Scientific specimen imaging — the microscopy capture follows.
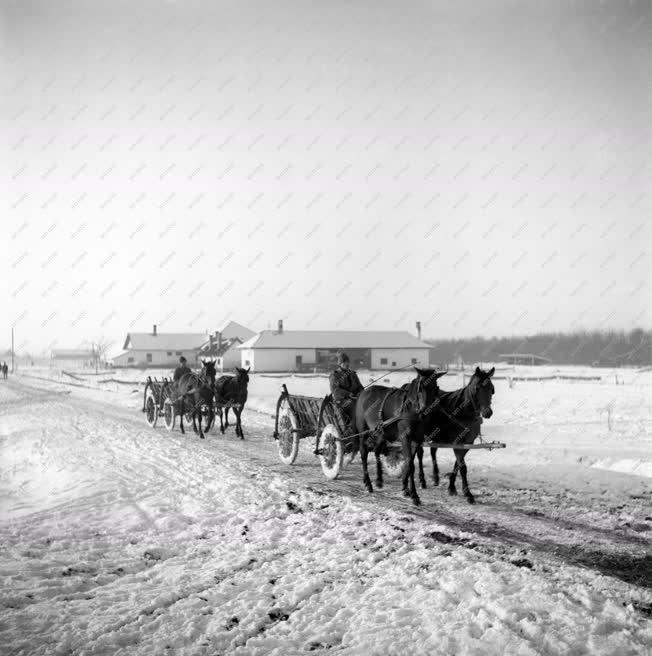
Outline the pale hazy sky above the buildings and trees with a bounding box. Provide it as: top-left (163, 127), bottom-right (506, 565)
top-left (0, 0), bottom-right (652, 352)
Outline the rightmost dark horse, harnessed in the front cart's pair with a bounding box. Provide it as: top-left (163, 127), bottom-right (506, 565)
top-left (417, 367), bottom-right (496, 503)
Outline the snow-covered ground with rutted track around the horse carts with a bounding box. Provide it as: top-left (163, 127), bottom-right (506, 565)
top-left (0, 367), bottom-right (652, 656)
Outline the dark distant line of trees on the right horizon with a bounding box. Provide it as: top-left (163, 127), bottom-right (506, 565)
top-left (425, 328), bottom-right (652, 367)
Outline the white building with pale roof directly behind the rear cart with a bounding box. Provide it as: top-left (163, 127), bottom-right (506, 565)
top-left (113, 326), bottom-right (208, 367)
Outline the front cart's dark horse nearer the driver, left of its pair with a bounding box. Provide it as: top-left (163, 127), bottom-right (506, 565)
top-left (355, 367), bottom-right (446, 506)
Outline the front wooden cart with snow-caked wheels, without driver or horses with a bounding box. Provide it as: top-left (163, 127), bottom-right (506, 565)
top-left (274, 384), bottom-right (506, 479)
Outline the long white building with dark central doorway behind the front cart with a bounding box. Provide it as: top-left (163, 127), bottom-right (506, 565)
top-left (238, 324), bottom-right (430, 372)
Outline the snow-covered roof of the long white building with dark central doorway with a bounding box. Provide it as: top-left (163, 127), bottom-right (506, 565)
top-left (238, 330), bottom-right (430, 349)
